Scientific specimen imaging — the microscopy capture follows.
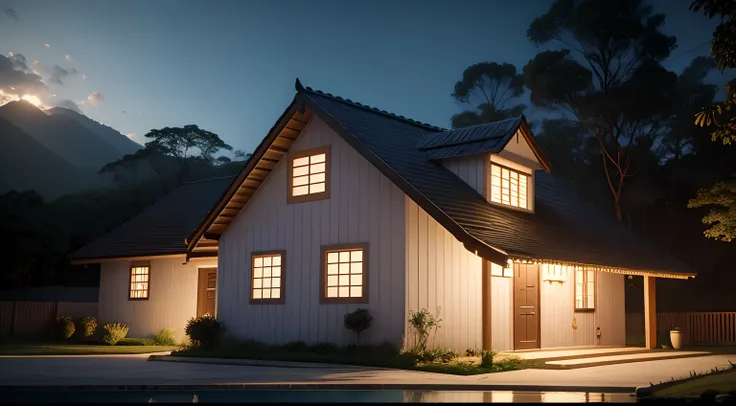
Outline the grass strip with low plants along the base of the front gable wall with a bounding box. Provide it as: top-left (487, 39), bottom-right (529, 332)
top-left (171, 341), bottom-right (526, 375)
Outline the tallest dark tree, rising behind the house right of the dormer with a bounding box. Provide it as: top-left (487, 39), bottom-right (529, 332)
top-left (523, 0), bottom-right (677, 221)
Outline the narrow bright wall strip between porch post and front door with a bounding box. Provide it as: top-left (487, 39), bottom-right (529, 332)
top-left (491, 276), bottom-right (514, 351)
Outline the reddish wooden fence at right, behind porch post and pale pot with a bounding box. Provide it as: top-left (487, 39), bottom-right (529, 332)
top-left (626, 312), bottom-right (736, 344)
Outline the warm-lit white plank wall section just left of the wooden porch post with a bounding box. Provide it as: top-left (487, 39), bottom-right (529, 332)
top-left (406, 197), bottom-right (482, 352)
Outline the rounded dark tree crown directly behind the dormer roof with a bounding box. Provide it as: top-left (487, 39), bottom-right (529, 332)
top-left (452, 62), bottom-right (526, 128)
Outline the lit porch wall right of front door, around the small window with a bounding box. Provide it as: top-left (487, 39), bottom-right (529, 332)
top-left (539, 272), bottom-right (626, 348)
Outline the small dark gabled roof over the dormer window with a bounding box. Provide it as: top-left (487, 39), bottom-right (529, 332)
top-left (417, 115), bottom-right (551, 172)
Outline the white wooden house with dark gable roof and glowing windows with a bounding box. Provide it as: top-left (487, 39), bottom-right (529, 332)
top-left (70, 80), bottom-right (695, 351)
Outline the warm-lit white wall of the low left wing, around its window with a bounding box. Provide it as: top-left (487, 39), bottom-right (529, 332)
top-left (98, 256), bottom-right (217, 341)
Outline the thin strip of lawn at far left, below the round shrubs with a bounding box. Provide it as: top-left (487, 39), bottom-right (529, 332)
top-left (0, 338), bottom-right (176, 355)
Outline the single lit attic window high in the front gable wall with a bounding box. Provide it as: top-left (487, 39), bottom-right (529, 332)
top-left (287, 146), bottom-right (330, 204)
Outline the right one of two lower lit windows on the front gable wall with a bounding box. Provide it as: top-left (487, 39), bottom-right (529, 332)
top-left (323, 246), bottom-right (367, 302)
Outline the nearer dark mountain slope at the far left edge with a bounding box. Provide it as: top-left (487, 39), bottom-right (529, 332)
top-left (0, 118), bottom-right (91, 199)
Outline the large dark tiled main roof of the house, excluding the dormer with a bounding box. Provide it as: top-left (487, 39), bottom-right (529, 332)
top-left (189, 80), bottom-right (695, 278)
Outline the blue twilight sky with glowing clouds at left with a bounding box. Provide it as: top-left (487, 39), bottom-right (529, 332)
top-left (0, 0), bottom-right (722, 152)
